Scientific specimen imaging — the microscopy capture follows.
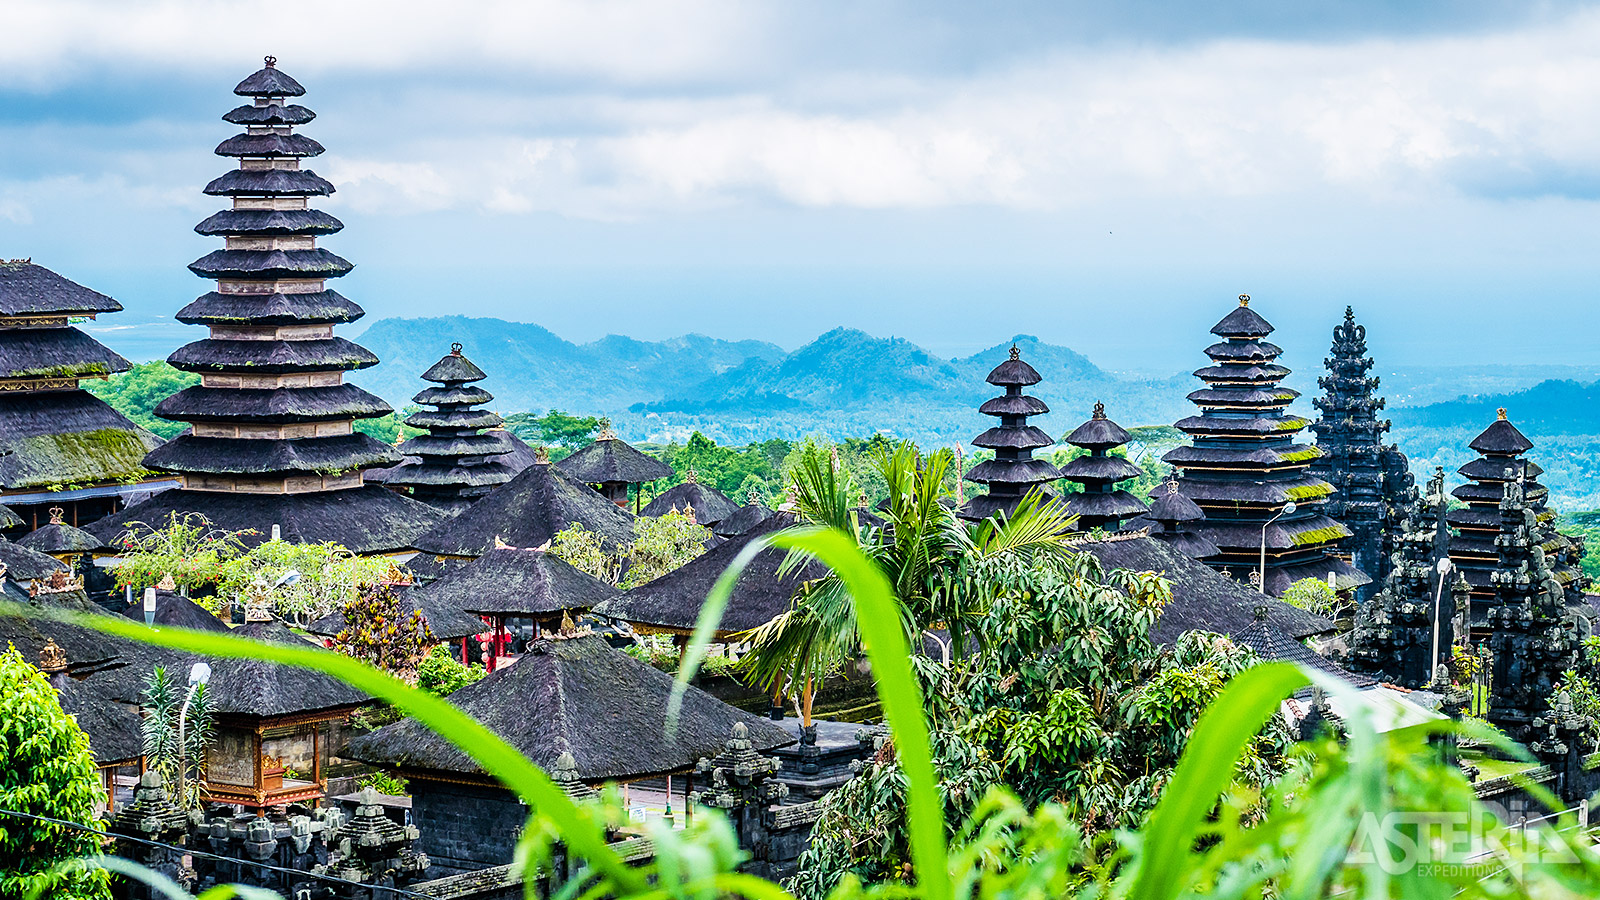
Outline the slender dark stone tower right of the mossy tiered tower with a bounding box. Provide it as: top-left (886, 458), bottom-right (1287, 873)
top-left (1310, 306), bottom-right (1432, 598)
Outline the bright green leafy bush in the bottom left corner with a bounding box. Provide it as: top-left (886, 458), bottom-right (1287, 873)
top-left (0, 647), bottom-right (110, 900)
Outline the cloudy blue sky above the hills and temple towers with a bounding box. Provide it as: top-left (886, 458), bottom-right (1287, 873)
top-left (0, 0), bottom-right (1600, 372)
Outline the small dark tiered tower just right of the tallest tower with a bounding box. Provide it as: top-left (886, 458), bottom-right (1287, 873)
top-left (384, 344), bottom-right (517, 514)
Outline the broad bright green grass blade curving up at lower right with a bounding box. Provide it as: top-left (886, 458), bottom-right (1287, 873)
top-left (1132, 660), bottom-right (1310, 900)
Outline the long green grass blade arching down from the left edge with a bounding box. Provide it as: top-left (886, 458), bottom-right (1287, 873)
top-left (48, 610), bottom-right (645, 894)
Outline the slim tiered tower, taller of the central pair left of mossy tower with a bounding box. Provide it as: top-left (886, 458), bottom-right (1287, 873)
top-left (960, 344), bottom-right (1061, 520)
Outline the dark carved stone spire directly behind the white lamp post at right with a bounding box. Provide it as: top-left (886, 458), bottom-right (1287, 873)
top-left (1349, 472), bottom-right (1467, 689)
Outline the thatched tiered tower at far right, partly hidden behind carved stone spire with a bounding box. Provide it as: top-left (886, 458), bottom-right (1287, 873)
top-left (1446, 410), bottom-right (1587, 639)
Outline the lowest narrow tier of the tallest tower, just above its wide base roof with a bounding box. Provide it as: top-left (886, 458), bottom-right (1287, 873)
top-left (144, 431), bottom-right (403, 476)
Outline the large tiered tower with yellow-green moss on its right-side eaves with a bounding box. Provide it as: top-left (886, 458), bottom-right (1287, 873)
top-left (1163, 295), bottom-right (1370, 596)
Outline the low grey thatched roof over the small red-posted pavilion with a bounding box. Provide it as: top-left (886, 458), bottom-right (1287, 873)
top-left (418, 548), bottom-right (619, 618)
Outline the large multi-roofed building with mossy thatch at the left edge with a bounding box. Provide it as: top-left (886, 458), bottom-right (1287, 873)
top-left (0, 259), bottom-right (178, 536)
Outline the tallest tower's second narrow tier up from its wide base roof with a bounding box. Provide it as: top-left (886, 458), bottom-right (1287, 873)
top-left (155, 384), bottom-right (394, 424)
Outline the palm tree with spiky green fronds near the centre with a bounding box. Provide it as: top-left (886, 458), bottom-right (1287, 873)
top-left (741, 444), bottom-right (1074, 725)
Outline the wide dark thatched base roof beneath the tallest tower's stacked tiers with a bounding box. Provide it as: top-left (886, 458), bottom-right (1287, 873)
top-left (85, 485), bottom-right (445, 554)
